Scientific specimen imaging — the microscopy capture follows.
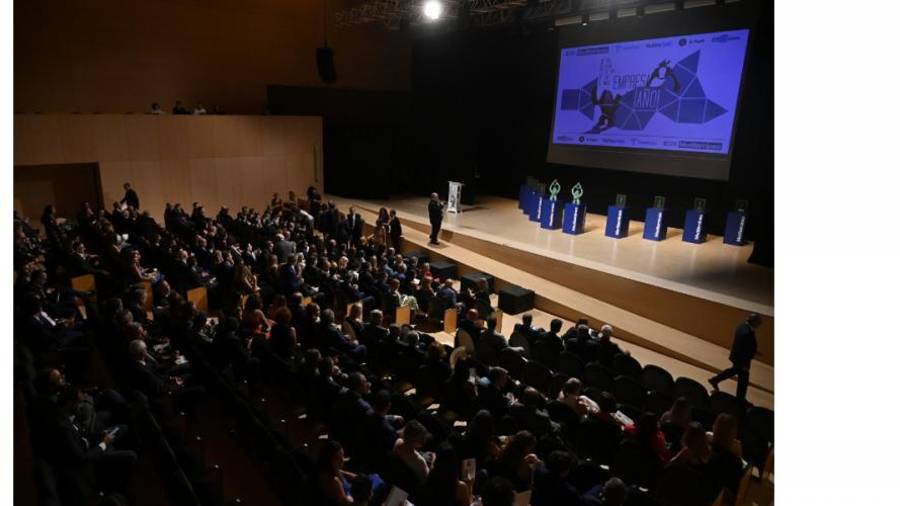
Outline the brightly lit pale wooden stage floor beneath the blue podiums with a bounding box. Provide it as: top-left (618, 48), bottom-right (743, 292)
top-left (342, 197), bottom-right (774, 308)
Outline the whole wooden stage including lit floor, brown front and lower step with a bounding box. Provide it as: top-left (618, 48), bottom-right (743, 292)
top-left (326, 196), bottom-right (774, 404)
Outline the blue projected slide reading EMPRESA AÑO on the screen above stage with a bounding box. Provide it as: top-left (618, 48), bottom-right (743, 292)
top-left (553, 30), bottom-right (750, 155)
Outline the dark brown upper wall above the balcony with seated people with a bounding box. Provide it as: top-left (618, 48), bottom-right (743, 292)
top-left (13, 0), bottom-right (411, 114)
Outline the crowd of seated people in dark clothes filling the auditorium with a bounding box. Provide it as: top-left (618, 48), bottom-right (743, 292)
top-left (14, 191), bottom-right (768, 506)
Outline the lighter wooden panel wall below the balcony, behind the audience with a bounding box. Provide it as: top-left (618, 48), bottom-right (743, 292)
top-left (14, 114), bottom-right (323, 219)
